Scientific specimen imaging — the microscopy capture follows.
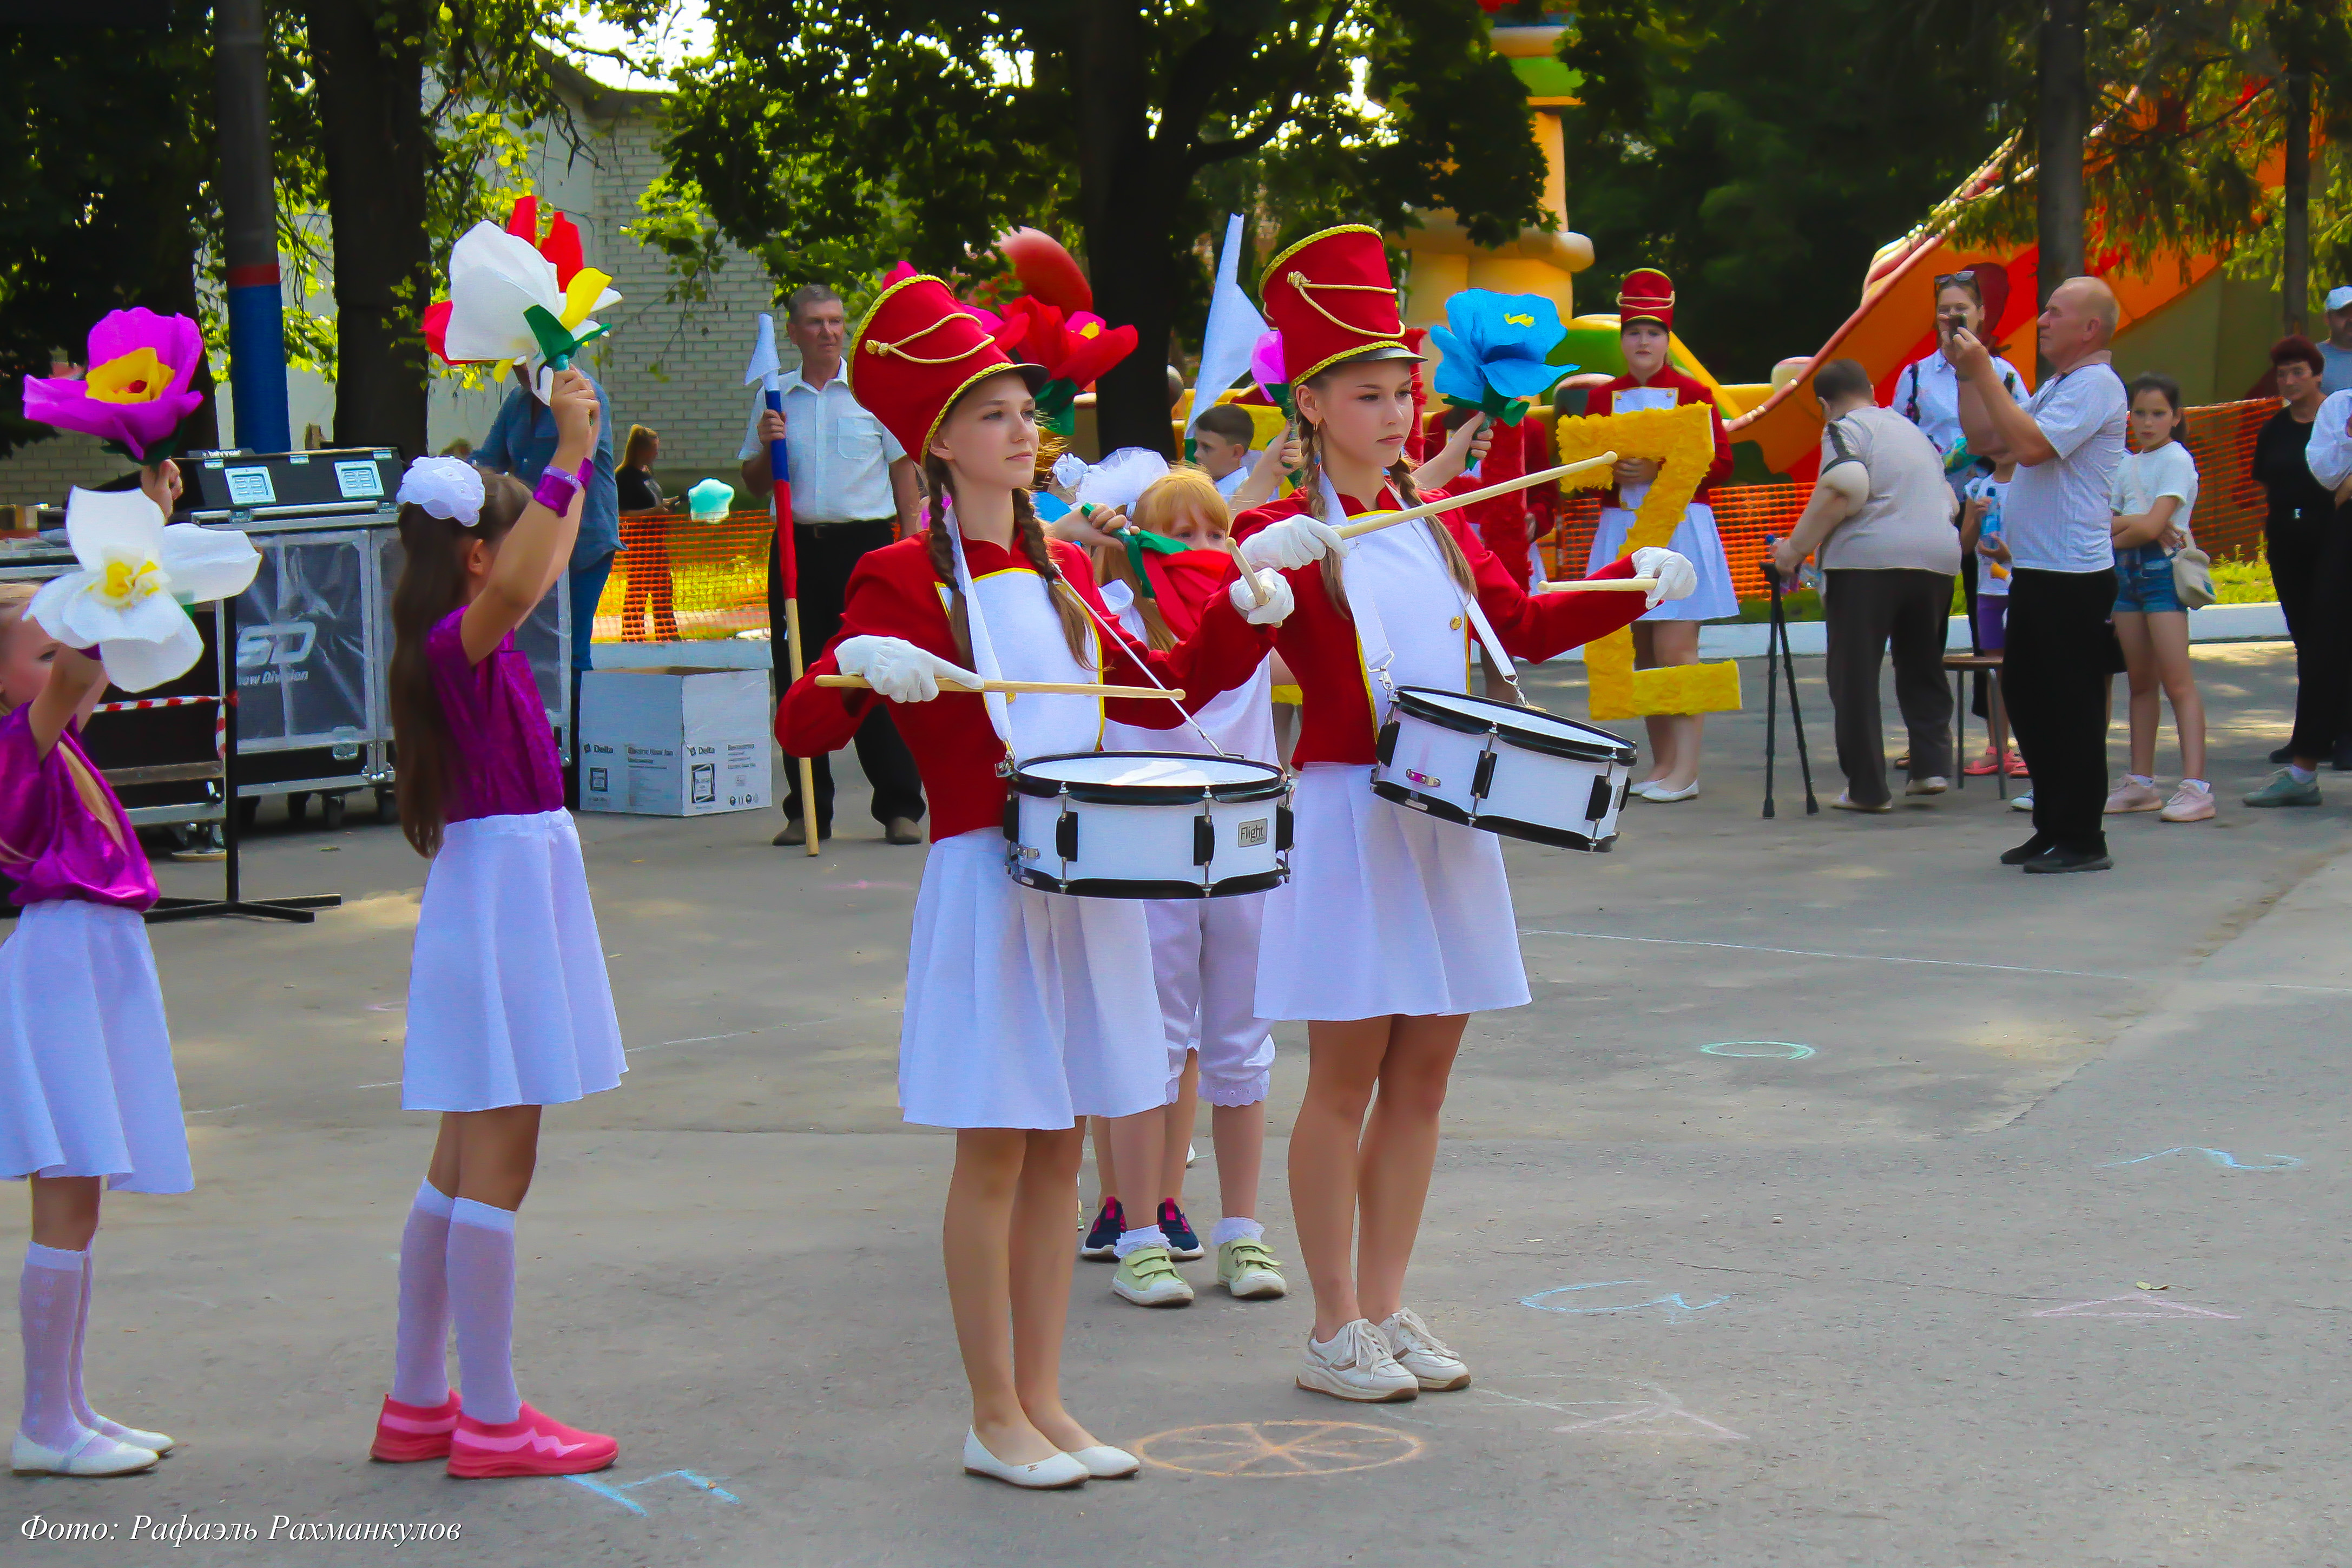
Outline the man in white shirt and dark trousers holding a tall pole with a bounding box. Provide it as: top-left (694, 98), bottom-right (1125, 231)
top-left (736, 282), bottom-right (922, 844)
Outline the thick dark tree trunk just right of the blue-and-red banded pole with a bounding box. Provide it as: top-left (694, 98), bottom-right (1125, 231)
top-left (306, 0), bottom-right (433, 456)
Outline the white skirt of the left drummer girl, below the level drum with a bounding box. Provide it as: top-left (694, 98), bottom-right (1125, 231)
top-left (899, 827), bottom-right (1167, 1129)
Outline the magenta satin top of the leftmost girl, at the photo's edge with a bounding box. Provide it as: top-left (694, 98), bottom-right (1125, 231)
top-left (0, 703), bottom-right (155, 910)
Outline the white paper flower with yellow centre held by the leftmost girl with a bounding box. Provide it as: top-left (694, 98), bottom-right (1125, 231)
top-left (26, 489), bottom-right (261, 691)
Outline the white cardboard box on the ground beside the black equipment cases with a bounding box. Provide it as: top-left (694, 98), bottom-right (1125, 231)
top-left (581, 666), bottom-right (774, 816)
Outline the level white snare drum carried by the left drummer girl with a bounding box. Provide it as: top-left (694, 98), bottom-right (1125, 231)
top-left (1004, 752), bottom-right (1292, 898)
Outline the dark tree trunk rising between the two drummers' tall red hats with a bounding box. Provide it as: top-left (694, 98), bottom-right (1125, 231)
top-left (1072, 0), bottom-right (1188, 454)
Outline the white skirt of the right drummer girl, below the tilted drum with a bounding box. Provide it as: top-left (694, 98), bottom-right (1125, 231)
top-left (1259, 762), bottom-right (1526, 1023)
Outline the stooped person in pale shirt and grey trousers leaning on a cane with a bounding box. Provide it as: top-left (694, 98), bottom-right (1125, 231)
top-left (1774, 360), bottom-right (1959, 811)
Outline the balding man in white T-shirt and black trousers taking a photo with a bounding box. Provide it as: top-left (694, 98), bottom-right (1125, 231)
top-left (1943, 278), bottom-right (2129, 872)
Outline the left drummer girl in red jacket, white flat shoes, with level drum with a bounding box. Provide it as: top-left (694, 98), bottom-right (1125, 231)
top-left (776, 278), bottom-right (1289, 1488)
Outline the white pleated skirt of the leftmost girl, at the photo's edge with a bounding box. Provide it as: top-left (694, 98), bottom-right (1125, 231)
top-left (0, 898), bottom-right (195, 1192)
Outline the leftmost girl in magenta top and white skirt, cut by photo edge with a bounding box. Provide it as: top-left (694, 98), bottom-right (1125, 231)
top-left (0, 583), bottom-right (195, 1477)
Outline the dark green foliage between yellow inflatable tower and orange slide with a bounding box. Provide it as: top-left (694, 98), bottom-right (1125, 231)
top-left (1559, 0), bottom-right (2030, 381)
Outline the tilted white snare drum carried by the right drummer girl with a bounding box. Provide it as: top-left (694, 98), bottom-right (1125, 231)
top-left (1371, 687), bottom-right (1635, 848)
